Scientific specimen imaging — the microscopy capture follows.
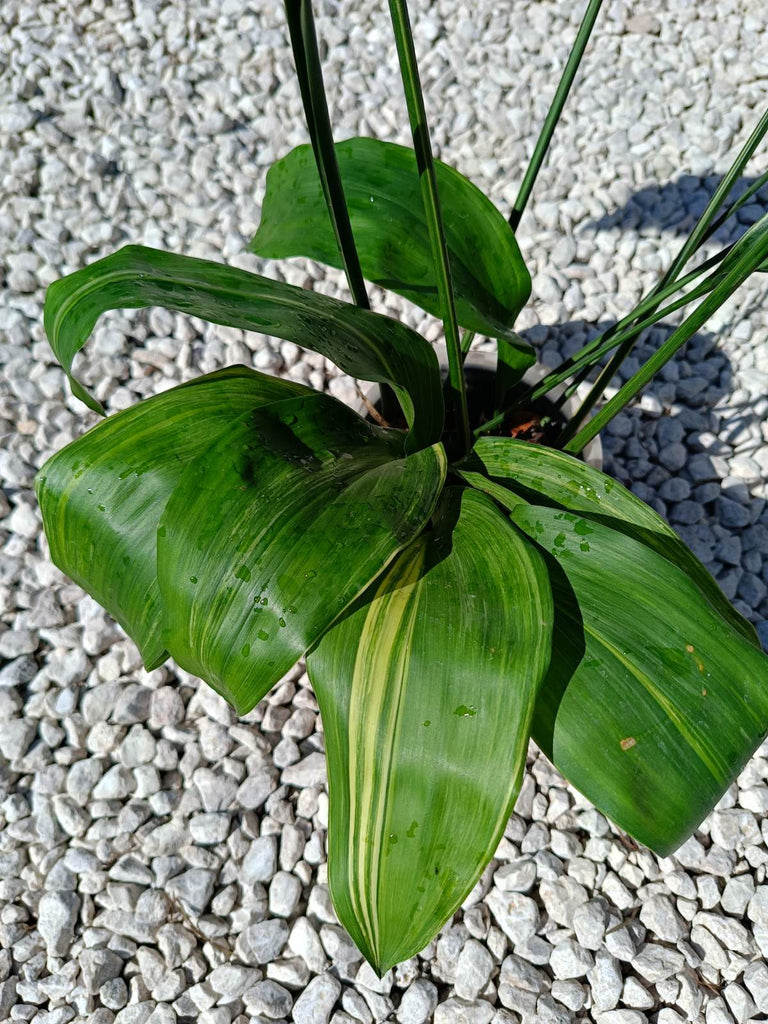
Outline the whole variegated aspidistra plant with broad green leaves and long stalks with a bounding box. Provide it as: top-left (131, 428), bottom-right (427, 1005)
top-left (37, 0), bottom-right (768, 972)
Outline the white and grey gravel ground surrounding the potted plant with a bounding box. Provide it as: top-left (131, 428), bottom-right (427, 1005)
top-left (0, 0), bottom-right (768, 1024)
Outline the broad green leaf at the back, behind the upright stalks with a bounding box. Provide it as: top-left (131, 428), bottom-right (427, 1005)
top-left (249, 138), bottom-right (534, 362)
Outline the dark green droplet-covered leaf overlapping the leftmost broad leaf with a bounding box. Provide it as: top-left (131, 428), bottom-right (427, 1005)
top-left (158, 394), bottom-right (445, 714)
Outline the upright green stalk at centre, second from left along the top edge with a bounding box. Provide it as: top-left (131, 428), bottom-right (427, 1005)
top-left (389, 0), bottom-right (471, 457)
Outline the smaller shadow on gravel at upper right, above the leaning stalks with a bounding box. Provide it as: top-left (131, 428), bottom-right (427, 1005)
top-left (586, 174), bottom-right (768, 245)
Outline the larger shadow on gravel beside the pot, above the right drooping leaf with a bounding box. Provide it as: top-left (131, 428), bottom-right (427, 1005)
top-left (521, 322), bottom-right (768, 630)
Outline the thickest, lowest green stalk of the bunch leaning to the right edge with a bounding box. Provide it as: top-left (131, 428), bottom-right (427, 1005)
top-left (564, 214), bottom-right (768, 454)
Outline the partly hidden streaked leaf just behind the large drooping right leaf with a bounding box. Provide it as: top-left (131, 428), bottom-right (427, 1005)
top-left (463, 437), bottom-right (760, 648)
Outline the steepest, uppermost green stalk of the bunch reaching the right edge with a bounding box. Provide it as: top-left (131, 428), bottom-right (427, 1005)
top-left (560, 110), bottom-right (768, 432)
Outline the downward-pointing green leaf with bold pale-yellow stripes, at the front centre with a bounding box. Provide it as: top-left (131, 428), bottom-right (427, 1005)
top-left (307, 487), bottom-right (552, 972)
